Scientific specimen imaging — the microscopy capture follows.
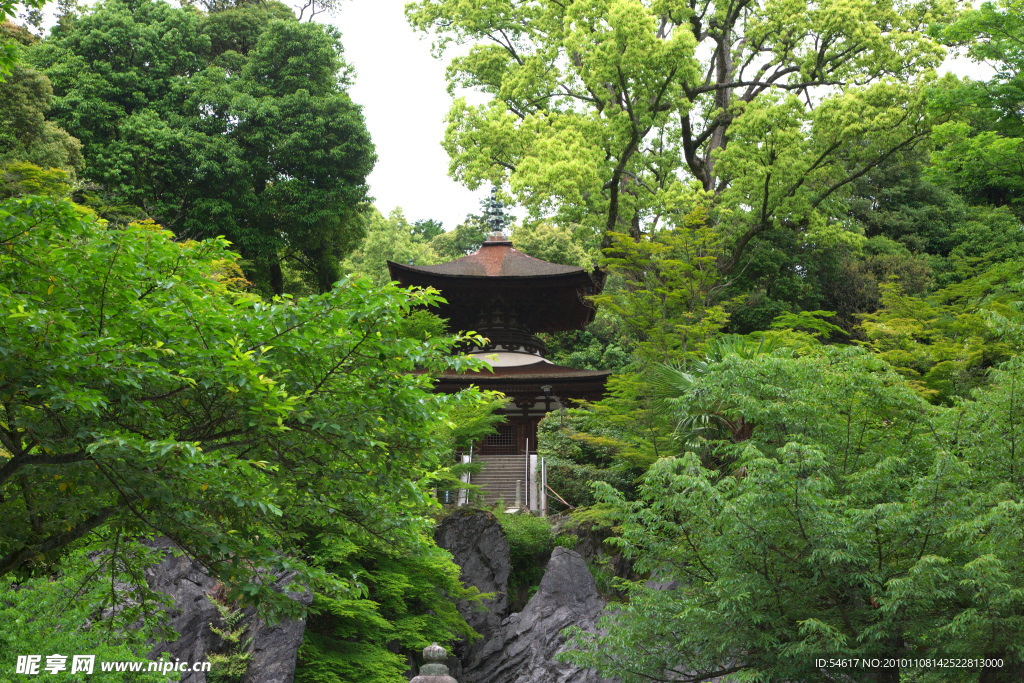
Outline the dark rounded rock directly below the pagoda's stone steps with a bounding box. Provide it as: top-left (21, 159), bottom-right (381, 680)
top-left (434, 508), bottom-right (511, 651)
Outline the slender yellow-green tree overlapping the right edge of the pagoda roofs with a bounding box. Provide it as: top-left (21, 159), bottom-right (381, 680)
top-left (548, 209), bottom-right (728, 469)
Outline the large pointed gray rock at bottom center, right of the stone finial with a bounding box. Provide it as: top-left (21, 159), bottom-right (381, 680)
top-left (462, 547), bottom-right (611, 683)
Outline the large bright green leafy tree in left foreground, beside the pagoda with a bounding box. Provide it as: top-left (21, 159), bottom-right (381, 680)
top-left (0, 197), bottom-right (490, 614)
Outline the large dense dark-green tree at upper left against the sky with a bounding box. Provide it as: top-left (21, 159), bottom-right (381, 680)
top-left (30, 0), bottom-right (375, 294)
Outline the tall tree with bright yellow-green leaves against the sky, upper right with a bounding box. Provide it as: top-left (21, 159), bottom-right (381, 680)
top-left (407, 0), bottom-right (951, 271)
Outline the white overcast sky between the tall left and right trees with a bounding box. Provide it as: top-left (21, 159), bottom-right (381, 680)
top-left (327, 0), bottom-right (986, 229)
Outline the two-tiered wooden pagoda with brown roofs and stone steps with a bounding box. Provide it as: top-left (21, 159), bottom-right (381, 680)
top-left (388, 192), bottom-right (611, 513)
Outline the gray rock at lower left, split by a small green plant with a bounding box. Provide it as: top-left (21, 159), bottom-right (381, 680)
top-left (145, 539), bottom-right (312, 683)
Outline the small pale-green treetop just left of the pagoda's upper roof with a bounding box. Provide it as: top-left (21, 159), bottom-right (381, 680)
top-left (341, 209), bottom-right (440, 285)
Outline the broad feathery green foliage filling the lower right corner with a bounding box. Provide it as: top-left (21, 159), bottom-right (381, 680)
top-left (563, 348), bottom-right (1024, 683)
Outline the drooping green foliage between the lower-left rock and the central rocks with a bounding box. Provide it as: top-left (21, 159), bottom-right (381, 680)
top-left (295, 535), bottom-right (480, 683)
